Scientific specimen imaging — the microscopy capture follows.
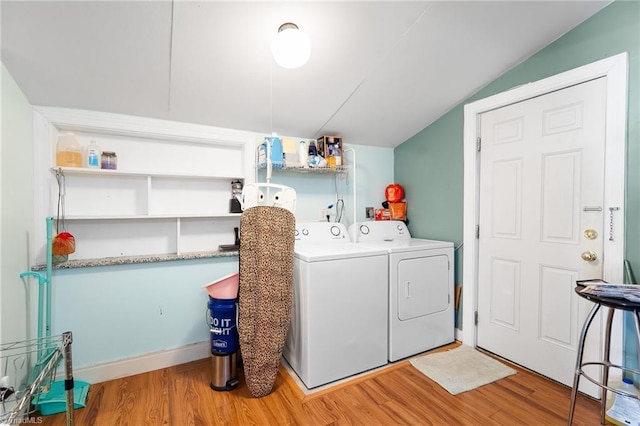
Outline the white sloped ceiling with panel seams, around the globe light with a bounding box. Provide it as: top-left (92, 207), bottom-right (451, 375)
top-left (0, 0), bottom-right (609, 147)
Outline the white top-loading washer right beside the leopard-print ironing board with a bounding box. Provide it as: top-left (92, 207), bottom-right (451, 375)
top-left (284, 222), bottom-right (389, 389)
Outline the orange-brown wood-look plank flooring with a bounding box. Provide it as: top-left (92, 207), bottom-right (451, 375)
top-left (42, 344), bottom-right (600, 426)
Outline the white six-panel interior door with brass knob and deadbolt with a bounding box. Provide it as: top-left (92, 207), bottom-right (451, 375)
top-left (477, 78), bottom-right (606, 396)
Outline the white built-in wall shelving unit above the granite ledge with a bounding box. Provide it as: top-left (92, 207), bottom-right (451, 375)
top-left (34, 107), bottom-right (256, 263)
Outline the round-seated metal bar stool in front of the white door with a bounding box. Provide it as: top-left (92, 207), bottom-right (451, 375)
top-left (569, 285), bottom-right (640, 425)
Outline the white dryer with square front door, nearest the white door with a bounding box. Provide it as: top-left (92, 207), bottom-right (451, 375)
top-left (349, 221), bottom-right (455, 361)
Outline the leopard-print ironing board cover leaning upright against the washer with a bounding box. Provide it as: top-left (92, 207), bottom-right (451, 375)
top-left (238, 206), bottom-right (295, 398)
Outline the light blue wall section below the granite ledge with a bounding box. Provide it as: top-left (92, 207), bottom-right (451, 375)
top-left (52, 257), bottom-right (238, 366)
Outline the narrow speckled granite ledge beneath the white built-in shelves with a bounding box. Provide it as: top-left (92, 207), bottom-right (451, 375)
top-left (31, 250), bottom-right (238, 271)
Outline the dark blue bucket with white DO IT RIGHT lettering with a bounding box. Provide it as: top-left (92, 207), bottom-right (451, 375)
top-left (208, 296), bottom-right (238, 355)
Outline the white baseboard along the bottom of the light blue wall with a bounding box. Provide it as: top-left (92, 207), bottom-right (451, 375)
top-left (72, 340), bottom-right (211, 383)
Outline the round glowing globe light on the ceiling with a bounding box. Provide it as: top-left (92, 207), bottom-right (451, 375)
top-left (271, 22), bottom-right (311, 69)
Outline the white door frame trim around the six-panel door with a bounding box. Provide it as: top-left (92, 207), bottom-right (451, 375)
top-left (462, 52), bottom-right (628, 347)
